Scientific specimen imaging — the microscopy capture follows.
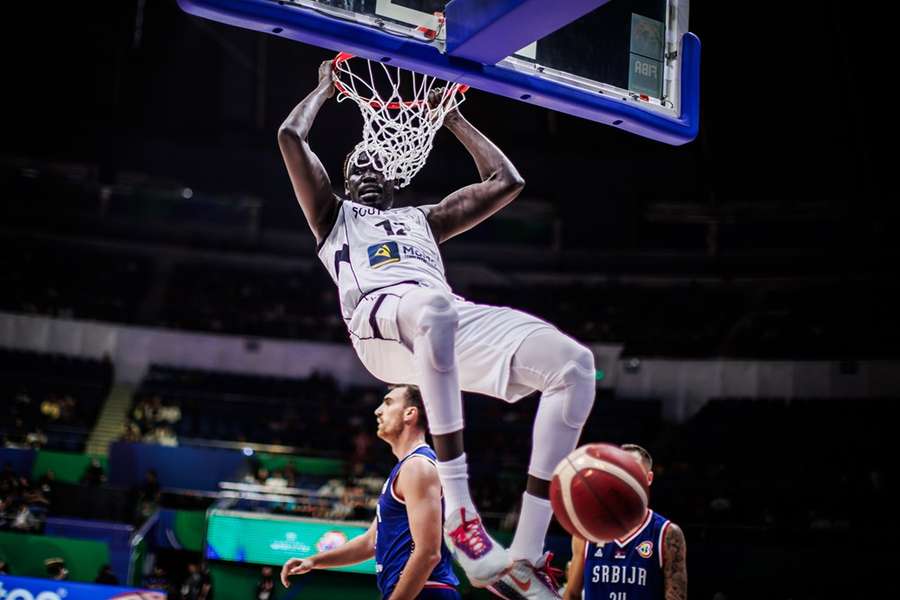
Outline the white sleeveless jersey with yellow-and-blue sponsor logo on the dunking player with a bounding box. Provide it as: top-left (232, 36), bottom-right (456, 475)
top-left (318, 200), bottom-right (452, 320)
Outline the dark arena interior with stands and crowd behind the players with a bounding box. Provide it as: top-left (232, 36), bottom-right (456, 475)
top-left (0, 0), bottom-right (900, 600)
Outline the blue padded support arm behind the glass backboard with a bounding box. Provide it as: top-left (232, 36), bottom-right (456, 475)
top-left (444, 0), bottom-right (609, 65)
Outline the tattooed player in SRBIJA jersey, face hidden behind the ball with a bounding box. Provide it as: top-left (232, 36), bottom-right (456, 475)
top-left (565, 444), bottom-right (687, 600)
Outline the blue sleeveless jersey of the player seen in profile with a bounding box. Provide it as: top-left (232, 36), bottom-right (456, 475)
top-left (375, 444), bottom-right (459, 598)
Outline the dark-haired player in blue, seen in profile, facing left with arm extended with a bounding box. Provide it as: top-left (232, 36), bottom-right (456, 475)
top-left (281, 385), bottom-right (460, 600)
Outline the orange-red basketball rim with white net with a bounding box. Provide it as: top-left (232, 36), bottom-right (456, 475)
top-left (332, 52), bottom-right (469, 188)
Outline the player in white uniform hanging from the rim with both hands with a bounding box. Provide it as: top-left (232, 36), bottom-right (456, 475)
top-left (278, 61), bottom-right (595, 598)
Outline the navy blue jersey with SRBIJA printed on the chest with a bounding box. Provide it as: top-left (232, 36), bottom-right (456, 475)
top-left (584, 510), bottom-right (669, 600)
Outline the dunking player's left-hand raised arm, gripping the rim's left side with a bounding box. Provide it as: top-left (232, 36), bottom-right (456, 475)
top-left (278, 61), bottom-right (337, 243)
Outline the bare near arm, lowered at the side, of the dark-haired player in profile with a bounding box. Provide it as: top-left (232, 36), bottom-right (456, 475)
top-left (391, 459), bottom-right (444, 600)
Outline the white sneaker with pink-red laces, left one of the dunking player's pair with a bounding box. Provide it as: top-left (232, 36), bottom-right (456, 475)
top-left (444, 508), bottom-right (512, 587)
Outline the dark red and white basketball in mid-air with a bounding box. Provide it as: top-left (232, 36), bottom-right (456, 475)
top-left (550, 444), bottom-right (649, 543)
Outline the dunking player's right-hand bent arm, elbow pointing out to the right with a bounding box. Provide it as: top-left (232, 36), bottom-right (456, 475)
top-left (420, 96), bottom-right (525, 244)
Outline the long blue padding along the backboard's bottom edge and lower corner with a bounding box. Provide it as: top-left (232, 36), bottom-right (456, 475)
top-left (178, 0), bottom-right (700, 145)
